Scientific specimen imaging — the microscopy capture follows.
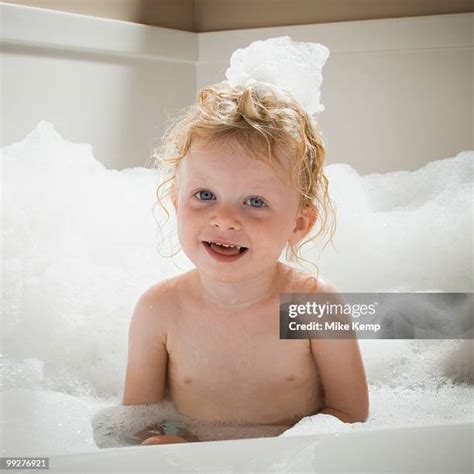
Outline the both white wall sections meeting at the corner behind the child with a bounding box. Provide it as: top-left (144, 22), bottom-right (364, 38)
top-left (1, 4), bottom-right (474, 174)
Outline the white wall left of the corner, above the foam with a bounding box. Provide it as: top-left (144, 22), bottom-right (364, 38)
top-left (1, 4), bottom-right (197, 169)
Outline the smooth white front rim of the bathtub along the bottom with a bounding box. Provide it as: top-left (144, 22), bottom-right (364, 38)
top-left (50, 423), bottom-right (474, 473)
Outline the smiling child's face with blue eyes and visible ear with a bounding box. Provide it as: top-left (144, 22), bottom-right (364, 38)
top-left (173, 142), bottom-right (314, 282)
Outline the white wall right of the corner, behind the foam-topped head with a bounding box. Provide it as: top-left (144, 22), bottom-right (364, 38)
top-left (197, 13), bottom-right (474, 174)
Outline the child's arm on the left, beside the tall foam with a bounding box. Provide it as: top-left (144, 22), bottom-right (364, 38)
top-left (122, 289), bottom-right (168, 405)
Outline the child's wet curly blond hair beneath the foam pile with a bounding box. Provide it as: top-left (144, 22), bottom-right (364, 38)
top-left (154, 81), bottom-right (335, 270)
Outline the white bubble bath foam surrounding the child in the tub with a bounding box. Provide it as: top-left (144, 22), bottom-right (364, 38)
top-left (1, 122), bottom-right (474, 456)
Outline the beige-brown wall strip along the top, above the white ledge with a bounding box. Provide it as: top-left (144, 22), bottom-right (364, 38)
top-left (5, 0), bottom-right (474, 32)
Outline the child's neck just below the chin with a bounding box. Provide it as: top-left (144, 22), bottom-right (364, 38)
top-left (195, 262), bottom-right (282, 311)
